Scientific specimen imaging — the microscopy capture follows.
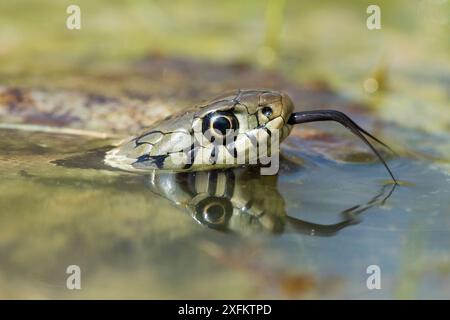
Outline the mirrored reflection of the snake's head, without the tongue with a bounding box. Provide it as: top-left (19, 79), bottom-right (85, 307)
top-left (150, 169), bottom-right (285, 234)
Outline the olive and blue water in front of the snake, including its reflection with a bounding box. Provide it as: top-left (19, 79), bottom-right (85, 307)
top-left (0, 124), bottom-right (450, 299)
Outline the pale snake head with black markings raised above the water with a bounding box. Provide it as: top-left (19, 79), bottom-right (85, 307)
top-left (105, 90), bottom-right (294, 171)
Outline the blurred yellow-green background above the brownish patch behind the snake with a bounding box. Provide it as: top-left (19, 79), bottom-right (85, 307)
top-left (0, 0), bottom-right (450, 132)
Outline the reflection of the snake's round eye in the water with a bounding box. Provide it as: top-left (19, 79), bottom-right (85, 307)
top-left (195, 197), bottom-right (233, 229)
